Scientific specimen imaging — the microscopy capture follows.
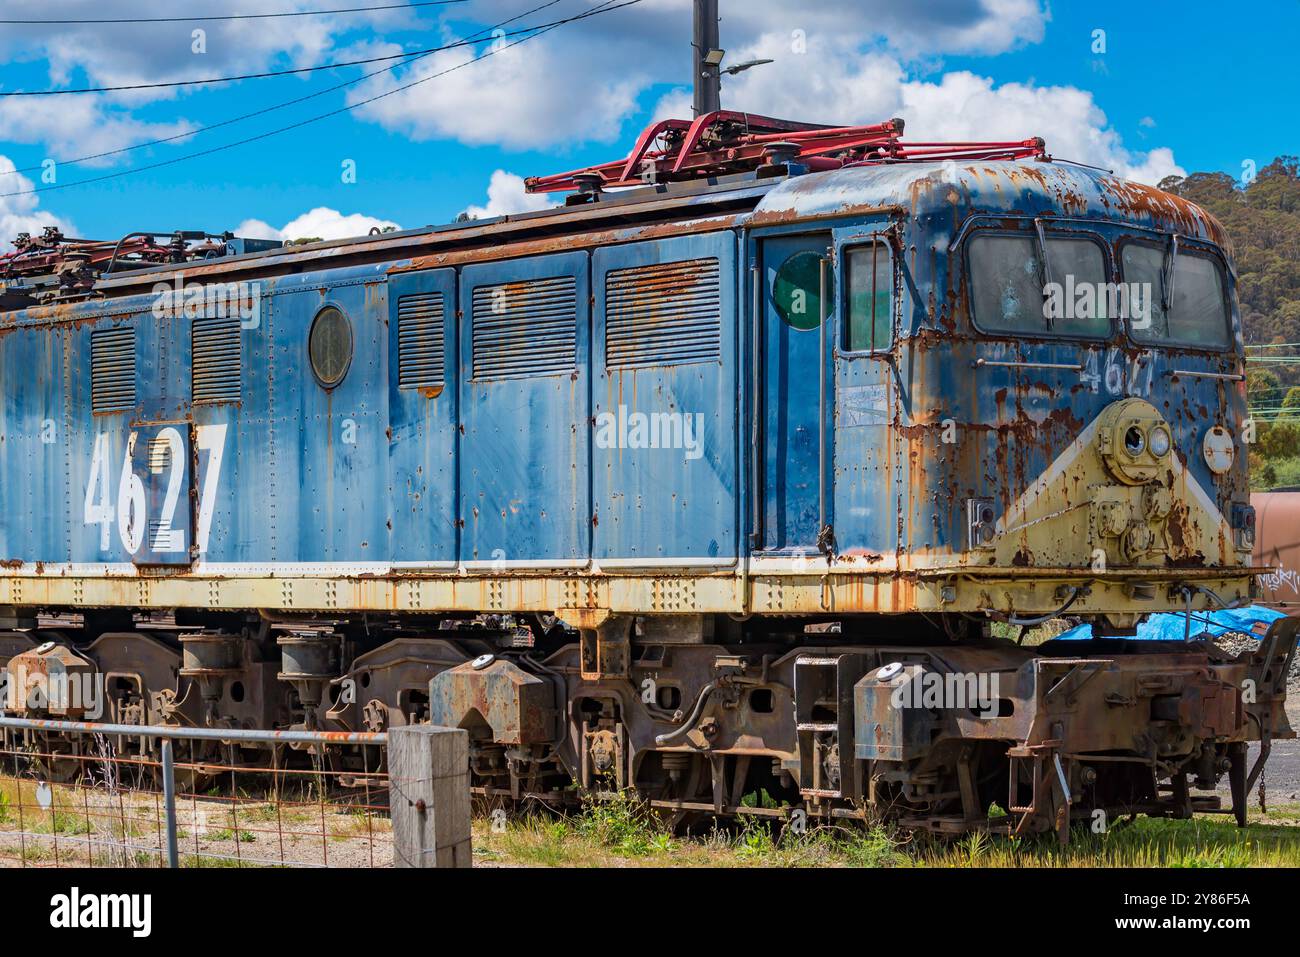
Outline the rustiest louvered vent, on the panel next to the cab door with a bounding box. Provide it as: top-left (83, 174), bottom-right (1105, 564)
top-left (605, 259), bottom-right (722, 369)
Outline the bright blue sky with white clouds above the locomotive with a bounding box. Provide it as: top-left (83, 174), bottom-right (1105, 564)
top-left (0, 0), bottom-right (1300, 247)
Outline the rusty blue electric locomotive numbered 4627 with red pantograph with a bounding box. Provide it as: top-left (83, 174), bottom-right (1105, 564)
top-left (0, 113), bottom-right (1296, 836)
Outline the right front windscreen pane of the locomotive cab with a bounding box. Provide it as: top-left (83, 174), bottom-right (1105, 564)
top-left (1119, 242), bottom-right (1231, 348)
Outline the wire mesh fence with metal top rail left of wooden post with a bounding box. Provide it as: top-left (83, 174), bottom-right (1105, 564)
top-left (0, 718), bottom-right (394, 867)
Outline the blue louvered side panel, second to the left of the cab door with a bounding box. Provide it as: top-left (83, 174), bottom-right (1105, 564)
top-left (459, 252), bottom-right (592, 570)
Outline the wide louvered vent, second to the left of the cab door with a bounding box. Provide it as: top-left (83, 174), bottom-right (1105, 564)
top-left (473, 276), bottom-right (577, 378)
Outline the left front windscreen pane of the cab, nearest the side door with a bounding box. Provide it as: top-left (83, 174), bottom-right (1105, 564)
top-left (969, 233), bottom-right (1110, 338)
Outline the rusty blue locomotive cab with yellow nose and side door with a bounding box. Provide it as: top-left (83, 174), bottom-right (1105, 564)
top-left (751, 163), bottom-right (1253, 633)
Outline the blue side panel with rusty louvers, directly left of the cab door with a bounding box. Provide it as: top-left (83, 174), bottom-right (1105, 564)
top-left (592, 233), bottom-right (737, 568)
